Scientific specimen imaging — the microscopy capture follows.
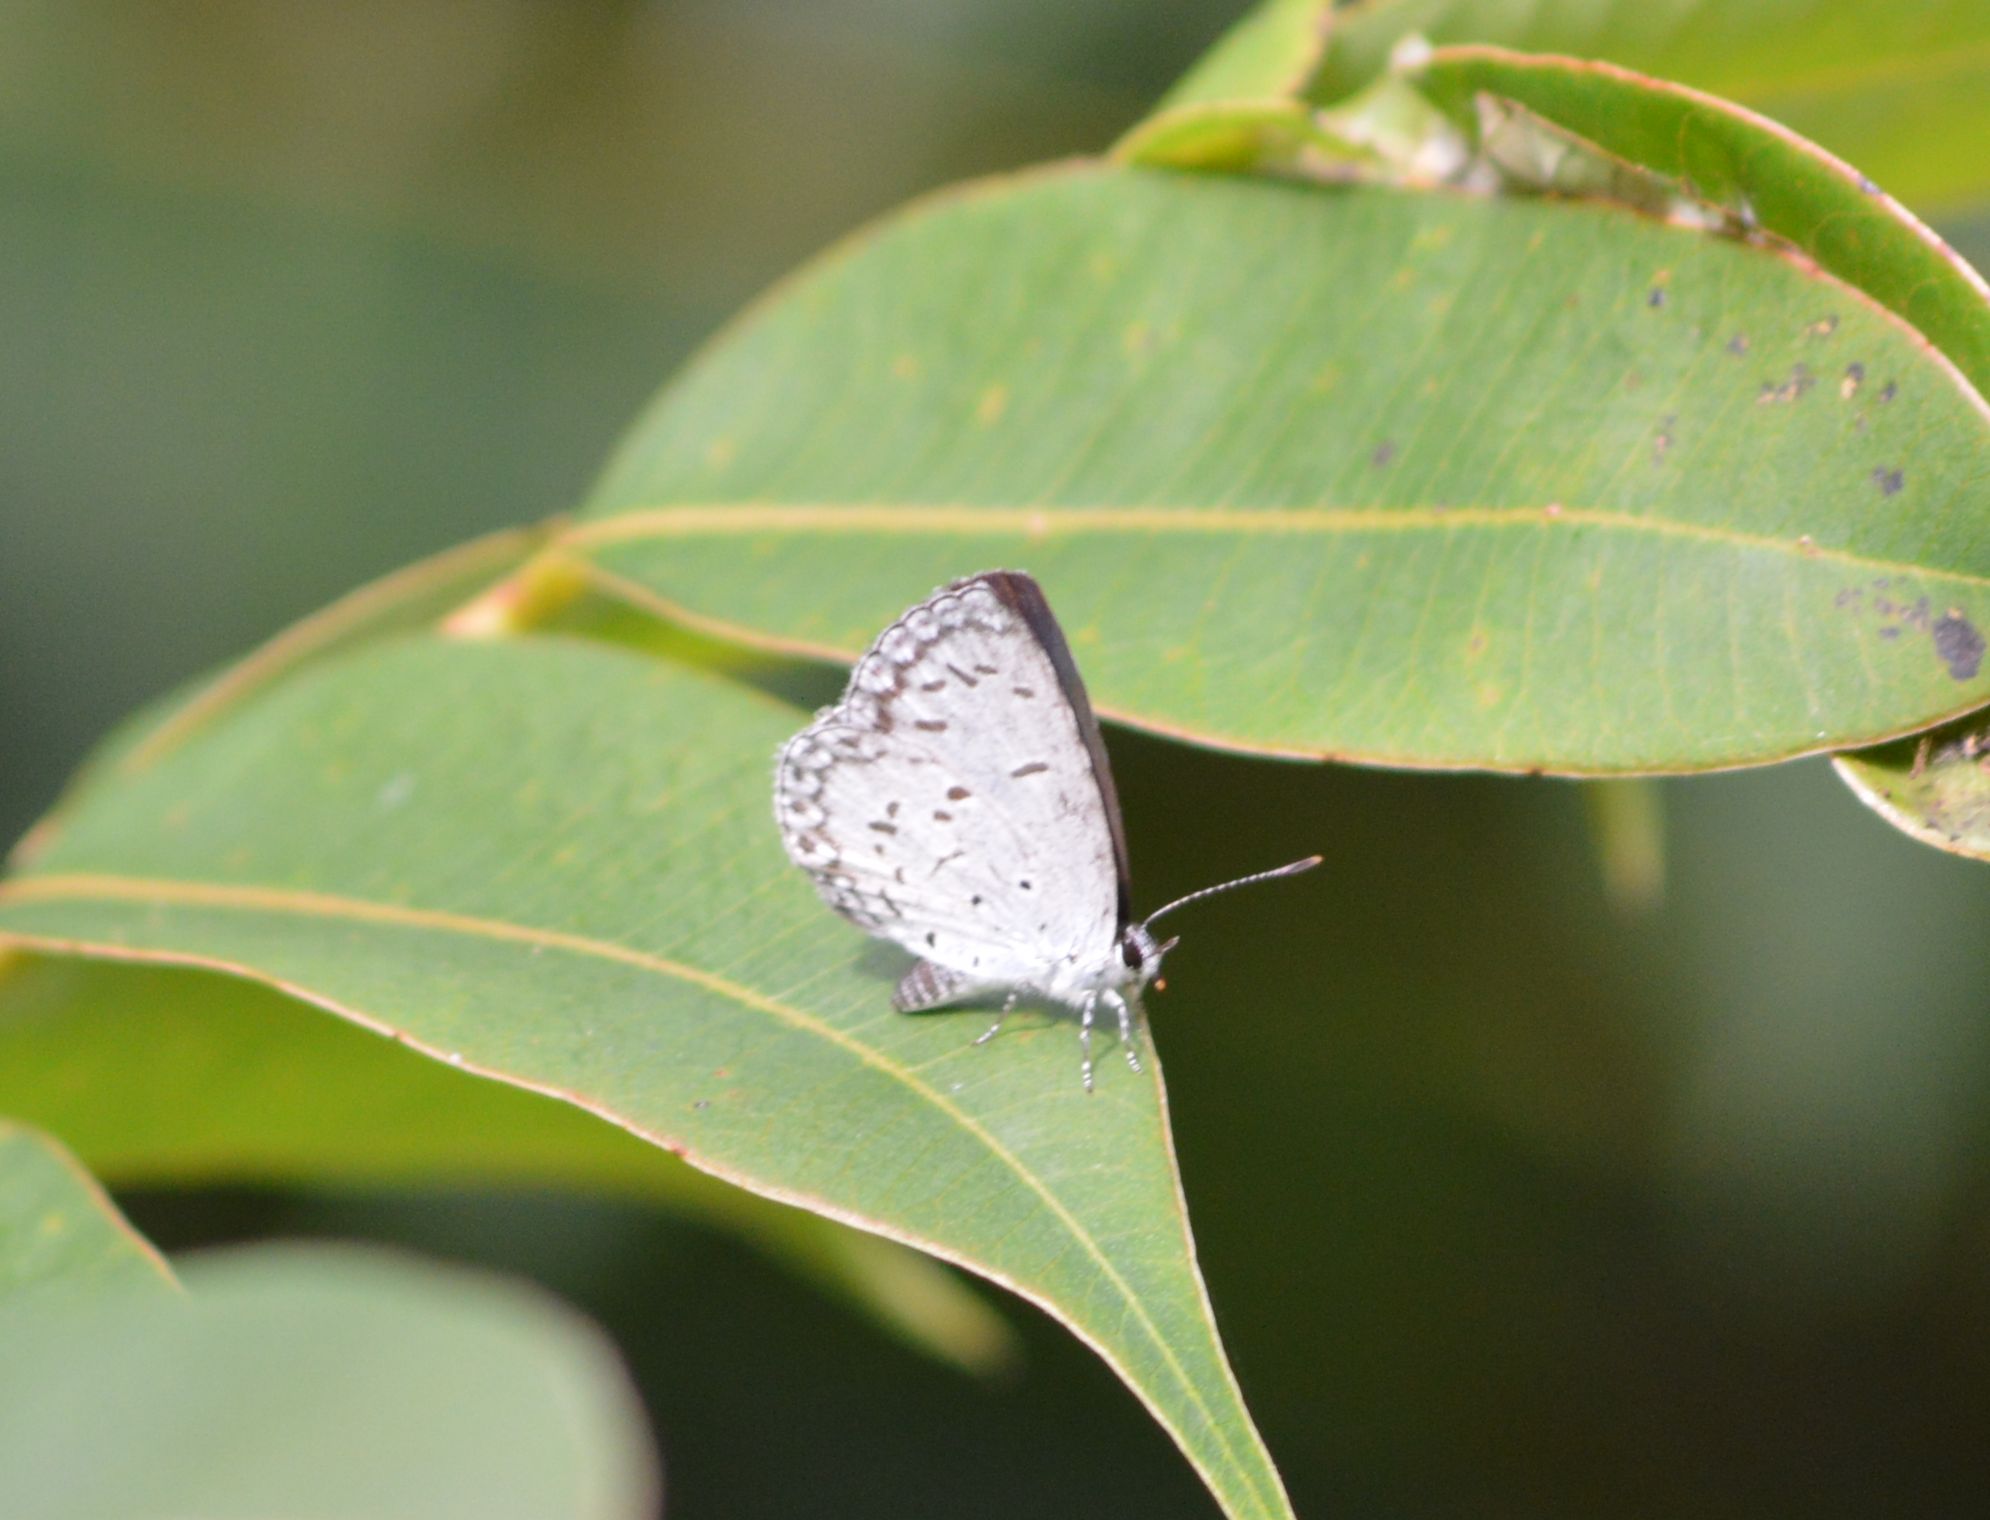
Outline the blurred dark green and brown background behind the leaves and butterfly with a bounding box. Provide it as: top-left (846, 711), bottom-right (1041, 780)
top-left (0, 0), bottom-right (1990, 1520)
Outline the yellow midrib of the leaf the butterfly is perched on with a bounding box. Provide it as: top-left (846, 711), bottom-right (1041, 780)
top-left (0, 871), bottom-right (1278, 1512)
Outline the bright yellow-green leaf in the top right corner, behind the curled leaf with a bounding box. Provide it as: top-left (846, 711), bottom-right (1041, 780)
top-left (1311, 0), bottom-right (1990, 211)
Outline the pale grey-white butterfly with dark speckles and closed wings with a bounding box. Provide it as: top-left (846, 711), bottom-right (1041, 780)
top-left (774, 571), bottom-right (1321, 1092)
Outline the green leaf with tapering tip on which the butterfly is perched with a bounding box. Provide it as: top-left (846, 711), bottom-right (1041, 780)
top-left (0, 639), bottom-right (1290, 1516)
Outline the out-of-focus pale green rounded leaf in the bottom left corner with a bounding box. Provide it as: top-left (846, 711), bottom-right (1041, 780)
top-left (0, 1247), bottom-right (657, 1520)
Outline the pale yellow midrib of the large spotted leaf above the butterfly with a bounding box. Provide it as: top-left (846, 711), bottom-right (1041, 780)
top-left (559, 501), bottom-right (1990, 587)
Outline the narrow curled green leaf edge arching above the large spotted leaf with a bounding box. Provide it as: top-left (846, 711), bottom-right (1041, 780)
top-left (1417, 48), bottom-right (1990, 392)
